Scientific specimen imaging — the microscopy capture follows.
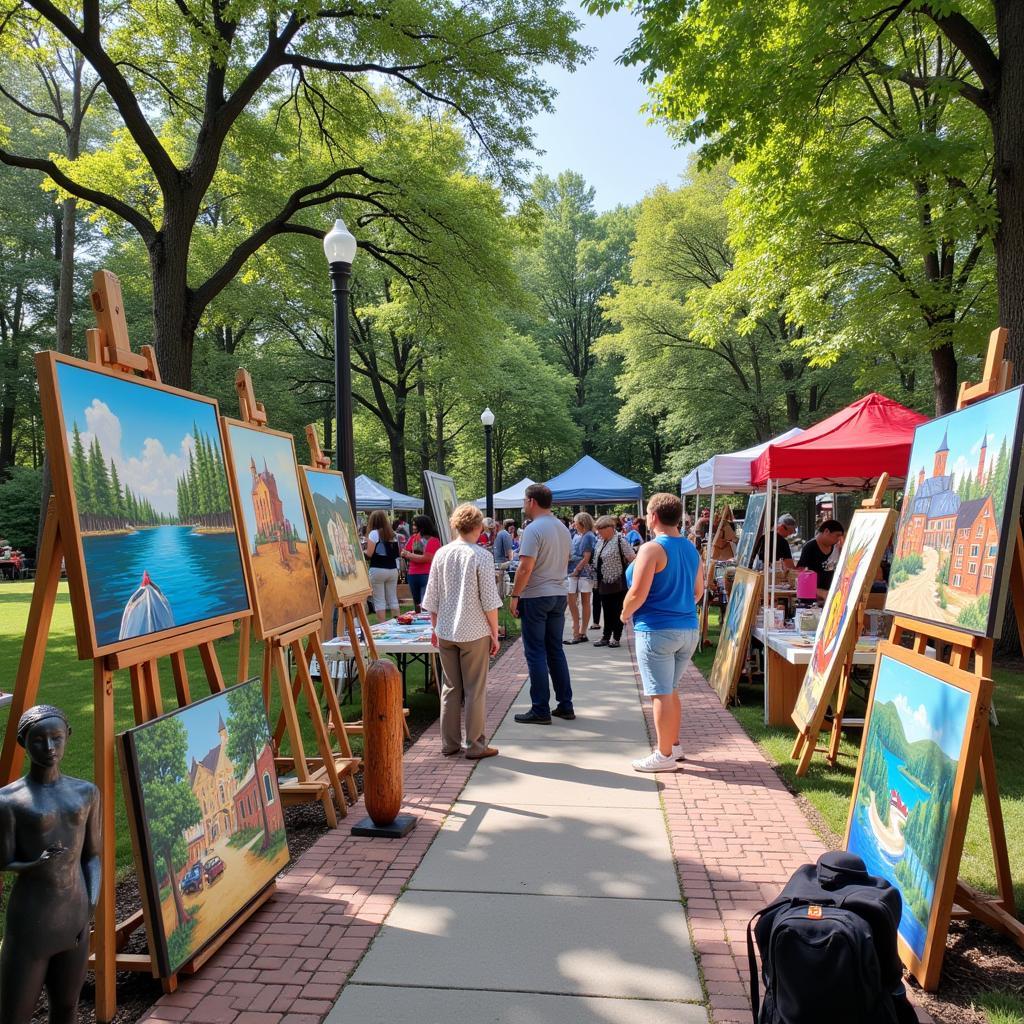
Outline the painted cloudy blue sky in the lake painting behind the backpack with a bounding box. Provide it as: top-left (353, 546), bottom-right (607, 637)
top-left (874, 657), bottom-right (971, 761)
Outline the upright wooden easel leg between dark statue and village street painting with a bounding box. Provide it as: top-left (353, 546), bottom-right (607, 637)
top-left (92, 658), bottom-right (117, 1024)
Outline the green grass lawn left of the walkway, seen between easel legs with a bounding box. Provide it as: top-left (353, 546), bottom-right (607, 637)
top-left (0, 583), bottom-right (438, 870)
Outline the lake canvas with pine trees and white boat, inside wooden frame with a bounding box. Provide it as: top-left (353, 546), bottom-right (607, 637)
top-left (53, 360), bottom-right (249, 649)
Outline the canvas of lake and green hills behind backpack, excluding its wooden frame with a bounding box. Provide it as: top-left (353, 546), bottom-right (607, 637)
top-left (846, 654), bottom-right (972, 961)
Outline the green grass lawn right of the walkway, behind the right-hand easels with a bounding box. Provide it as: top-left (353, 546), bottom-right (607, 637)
top-left (696, 606), bottom-right (1024, 913)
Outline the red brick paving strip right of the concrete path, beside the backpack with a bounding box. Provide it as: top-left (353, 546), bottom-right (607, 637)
top-left (630, 635), bottom-right (931, 1024)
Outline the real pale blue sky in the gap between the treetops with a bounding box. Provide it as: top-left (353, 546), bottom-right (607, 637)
top-left (534, 8), bottom-right (688, 211)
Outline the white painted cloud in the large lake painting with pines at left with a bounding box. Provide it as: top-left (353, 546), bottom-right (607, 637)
top-left (69, 398), bottom-right (196, 514)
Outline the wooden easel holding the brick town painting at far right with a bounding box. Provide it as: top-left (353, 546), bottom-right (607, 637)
top-left (890, 328), bottom-right (1024, 974)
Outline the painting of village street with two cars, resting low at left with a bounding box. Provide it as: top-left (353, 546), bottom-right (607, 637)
top-left (121, 679), bottom-right (289, 975)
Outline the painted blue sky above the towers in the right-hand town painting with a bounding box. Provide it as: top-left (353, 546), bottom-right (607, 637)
top-left (909, 388), bottom-right (1021, 491)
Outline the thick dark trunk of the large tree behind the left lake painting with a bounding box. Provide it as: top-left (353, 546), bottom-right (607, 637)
top-left (150, 212), bottom-right (197, 390)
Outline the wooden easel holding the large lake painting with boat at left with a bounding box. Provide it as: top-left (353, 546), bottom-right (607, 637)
top-left (0, 270), bottom-right (273, 1022)
